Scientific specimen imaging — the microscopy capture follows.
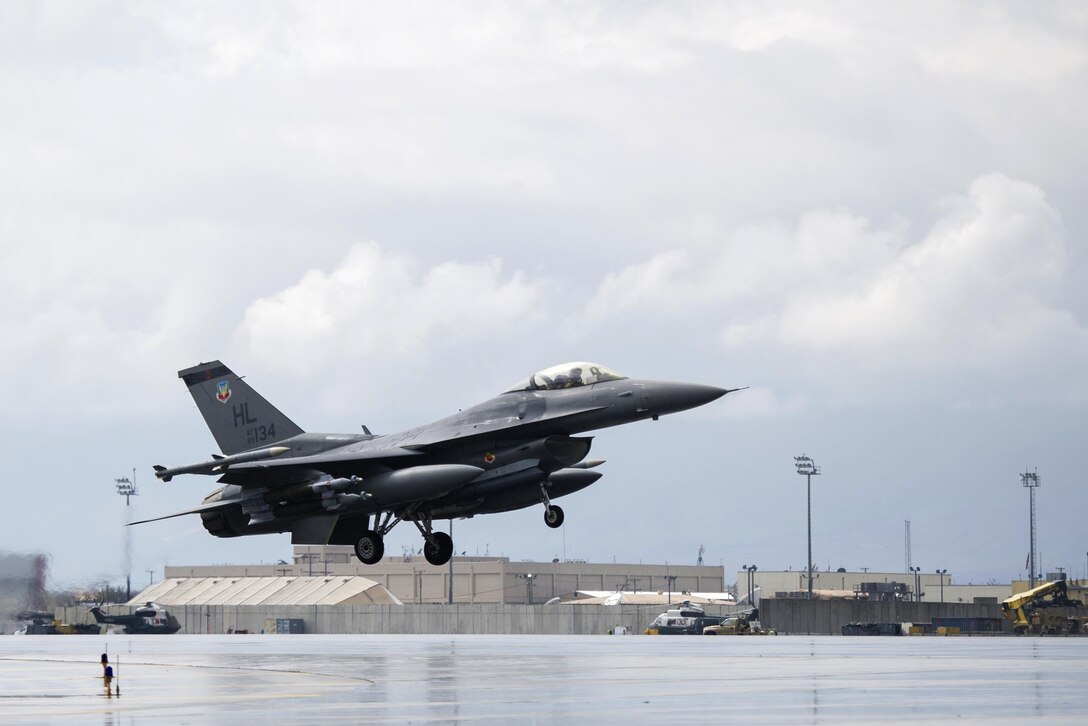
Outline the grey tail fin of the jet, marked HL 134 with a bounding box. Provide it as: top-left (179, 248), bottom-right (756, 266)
top-left (177, 360), bottom-right (302, 455)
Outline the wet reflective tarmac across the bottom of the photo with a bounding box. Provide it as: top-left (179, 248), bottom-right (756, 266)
top-left (0, 635), bottom-right (1088, 725)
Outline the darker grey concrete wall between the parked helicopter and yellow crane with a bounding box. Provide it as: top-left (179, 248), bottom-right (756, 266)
top-left (759, 598), bottom-right (1011, 636)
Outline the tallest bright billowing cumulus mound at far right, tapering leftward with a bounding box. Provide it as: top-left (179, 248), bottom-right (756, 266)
top-left (778, 174), bottom-right (1074, 370)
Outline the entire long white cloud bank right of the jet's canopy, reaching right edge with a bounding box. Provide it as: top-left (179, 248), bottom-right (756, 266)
top-left (590, 173), bottom-right (1088, 397)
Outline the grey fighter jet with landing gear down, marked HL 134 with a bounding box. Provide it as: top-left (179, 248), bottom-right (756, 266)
top-left (133, 360), bottom-right (740, 565)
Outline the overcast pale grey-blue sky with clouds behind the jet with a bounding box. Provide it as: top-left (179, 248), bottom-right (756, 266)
top-left (0, 1), bottom-right (1088, 585)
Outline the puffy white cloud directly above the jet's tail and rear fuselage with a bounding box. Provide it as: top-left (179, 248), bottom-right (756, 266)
top-left (239, 242), bottom-right (546, 371)
